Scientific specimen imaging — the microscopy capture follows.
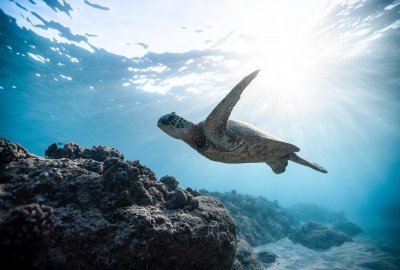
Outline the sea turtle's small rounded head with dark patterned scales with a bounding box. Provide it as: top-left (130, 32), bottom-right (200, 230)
top-left (157, 112), bottom-right (193, 140)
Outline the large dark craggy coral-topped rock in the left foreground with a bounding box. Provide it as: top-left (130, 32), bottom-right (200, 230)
top-left (0, 139), bottom-right (236, 269)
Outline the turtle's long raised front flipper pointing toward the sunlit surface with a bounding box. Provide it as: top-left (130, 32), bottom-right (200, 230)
top-left (203, 70), bottom-right (259, 141)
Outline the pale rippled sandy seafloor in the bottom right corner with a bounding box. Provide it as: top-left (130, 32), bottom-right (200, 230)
top-left (254, 220), bottom-right (400, 270)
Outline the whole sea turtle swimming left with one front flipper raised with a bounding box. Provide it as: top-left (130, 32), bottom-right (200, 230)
top-left (157, 70), bottom-right (327, 174)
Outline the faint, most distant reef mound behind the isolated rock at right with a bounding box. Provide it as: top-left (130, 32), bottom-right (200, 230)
top-left (285, 203), bottom-right (347, 224)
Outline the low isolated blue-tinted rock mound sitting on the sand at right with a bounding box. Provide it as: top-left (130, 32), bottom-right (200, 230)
top-left (289, 222), bottom-right (353, 250)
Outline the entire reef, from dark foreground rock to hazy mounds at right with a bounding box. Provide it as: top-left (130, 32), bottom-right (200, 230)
top-left (0, 139), bottom-right (361, 270)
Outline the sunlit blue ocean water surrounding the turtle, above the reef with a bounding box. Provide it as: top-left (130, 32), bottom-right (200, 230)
top-left (0, 0), bottom-right (400, 269)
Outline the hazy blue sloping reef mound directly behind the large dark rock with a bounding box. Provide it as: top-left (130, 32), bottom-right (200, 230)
top-left (200, 190), bottom-right (292, 246)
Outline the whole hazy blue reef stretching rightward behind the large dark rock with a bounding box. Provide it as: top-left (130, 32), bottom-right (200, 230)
top-left (200, 190), bottom-right (362, 252)
